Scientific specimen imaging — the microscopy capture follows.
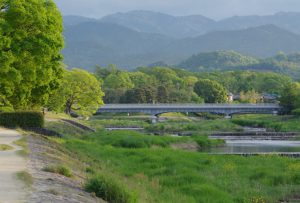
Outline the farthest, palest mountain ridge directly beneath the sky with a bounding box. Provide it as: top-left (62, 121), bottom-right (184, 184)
top-left (64, 11), bottom-right (300, 39)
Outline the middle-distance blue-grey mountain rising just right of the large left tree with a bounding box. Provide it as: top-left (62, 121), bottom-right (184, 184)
top-left (63, 21), bottom-right (173, 70)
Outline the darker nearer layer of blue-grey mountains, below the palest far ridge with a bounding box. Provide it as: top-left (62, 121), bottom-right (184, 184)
top-left (63, 21), bottom-right (300, 70)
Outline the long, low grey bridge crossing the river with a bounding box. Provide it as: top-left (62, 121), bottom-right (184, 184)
top-left (97, 104), bottom-right (283, 117)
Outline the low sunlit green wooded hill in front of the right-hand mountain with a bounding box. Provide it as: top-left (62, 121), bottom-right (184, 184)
top-left (178, 51), bottom-right (300, 79)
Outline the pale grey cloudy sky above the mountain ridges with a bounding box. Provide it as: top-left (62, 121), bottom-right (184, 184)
top-left (54, 0), bottom-right (300, 20)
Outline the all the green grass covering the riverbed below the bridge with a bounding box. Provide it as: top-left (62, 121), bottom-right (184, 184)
top-left (44, 116), bottom-right (300, 203)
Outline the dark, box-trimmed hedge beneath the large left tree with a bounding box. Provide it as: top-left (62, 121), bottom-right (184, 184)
top-left (0, 112), bottom-right (44, 128)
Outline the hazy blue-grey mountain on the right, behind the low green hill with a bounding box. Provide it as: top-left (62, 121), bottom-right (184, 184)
top-left (167, 25), bottom-right (300, 62)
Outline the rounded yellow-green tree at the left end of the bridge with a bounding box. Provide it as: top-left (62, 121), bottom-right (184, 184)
top-left (48, 69), bottom-right (104, 116)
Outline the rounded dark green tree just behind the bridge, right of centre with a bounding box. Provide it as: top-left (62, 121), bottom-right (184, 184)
top-left (194, 79), bottom-right (227, 103)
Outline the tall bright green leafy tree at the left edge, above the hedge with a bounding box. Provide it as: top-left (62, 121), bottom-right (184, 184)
top-left (0, 0), bottom-right (64, 109)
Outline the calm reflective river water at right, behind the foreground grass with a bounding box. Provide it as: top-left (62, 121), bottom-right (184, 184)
top-left (209, 140), bottom-right (300, 153)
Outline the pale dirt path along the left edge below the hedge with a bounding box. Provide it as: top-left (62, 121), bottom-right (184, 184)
top-left (0, 128), bottom-right (27, 203)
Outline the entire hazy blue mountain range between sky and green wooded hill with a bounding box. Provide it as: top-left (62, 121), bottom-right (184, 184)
top-left (63, 11), bottom-right (300, 70)
